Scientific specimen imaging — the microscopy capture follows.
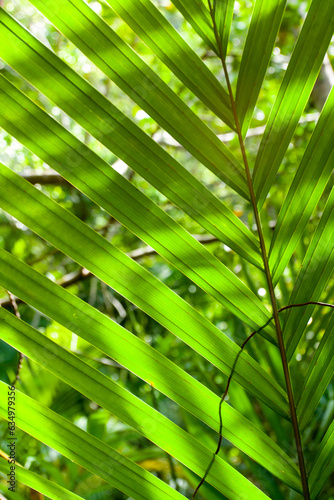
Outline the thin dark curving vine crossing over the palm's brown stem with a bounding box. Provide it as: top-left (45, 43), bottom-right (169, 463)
top-left (191, 301), bottom-right (334, 500)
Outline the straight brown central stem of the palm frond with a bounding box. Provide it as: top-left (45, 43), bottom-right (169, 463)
top-left (208, 0), bottom-right (310, 500)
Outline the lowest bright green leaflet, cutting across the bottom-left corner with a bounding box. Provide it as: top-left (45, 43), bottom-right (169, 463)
top-left (0, 458), bottom-right (83, 500)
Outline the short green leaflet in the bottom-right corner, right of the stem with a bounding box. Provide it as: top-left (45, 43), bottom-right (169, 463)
top-left (309, 421), bottom-right (334, 500)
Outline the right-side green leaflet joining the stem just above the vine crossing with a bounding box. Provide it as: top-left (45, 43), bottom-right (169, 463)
top-left (269, 89), bottom-right (334, 283)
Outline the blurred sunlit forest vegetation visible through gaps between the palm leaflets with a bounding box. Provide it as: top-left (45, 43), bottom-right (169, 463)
top-left (0, 0), bottom-right (334, 500)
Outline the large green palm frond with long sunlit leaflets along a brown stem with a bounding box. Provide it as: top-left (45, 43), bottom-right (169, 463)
top-left (0, 0), bottom-right (334, 500)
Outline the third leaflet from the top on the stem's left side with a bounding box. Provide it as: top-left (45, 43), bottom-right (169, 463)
top-left (31, 0), bottom-right (249, 198)
